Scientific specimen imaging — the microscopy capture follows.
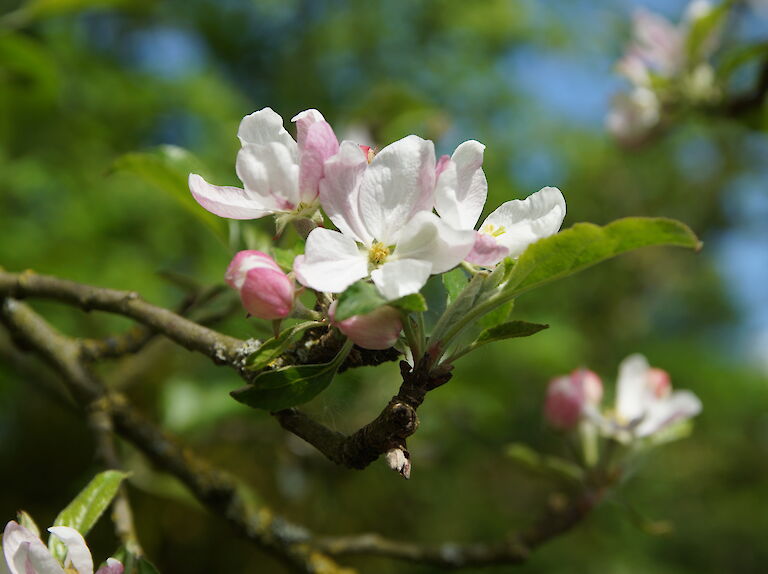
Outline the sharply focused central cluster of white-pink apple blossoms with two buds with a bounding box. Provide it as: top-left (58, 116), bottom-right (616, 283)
top-left (189, 108), bottom-right (565, 349)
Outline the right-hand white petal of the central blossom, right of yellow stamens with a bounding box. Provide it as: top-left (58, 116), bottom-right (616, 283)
top-left (394, 211), bottom-right (475, 274)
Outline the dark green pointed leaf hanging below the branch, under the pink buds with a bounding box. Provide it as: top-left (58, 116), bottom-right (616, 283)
top-left (230, 340), bottom-right (352, 411)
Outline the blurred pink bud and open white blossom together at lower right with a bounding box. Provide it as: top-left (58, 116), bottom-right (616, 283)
top-left (544, 354), bottom-right (701, 444)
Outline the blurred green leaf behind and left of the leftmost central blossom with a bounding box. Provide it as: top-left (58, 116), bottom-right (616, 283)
top-left (112, 145), bottom-right (229, 243)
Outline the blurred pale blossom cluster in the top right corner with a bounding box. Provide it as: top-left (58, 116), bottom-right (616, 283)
top-left (606, 0), bottom-right (720, 143)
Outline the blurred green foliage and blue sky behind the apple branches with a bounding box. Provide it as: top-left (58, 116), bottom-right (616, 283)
top-left (0, 0), bottom-right (768, 574)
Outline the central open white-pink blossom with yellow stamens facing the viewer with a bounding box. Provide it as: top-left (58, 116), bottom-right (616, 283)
top-left (293, 135), bottom-right (474, 300)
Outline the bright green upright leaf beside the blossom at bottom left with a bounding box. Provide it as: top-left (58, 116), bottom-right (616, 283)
top-left (48, 470), bottom-right (128, 563)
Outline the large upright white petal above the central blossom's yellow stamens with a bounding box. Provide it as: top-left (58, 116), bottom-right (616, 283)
top-left (359, 135), bottom-right (435, 245)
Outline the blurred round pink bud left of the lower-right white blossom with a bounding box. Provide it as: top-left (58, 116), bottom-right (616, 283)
top-left (544, 369), bottom-right (603, 430)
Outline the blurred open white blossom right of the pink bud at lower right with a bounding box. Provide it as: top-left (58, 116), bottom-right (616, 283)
top-left (593, 354), bottom-right (701, 443)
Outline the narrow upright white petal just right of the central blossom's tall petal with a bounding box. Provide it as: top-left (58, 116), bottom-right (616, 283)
top-left (435, 140), bottom-right (488, 229)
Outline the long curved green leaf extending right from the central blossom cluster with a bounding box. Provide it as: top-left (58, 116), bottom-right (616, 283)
top-left (504, 217), bottom-right (701, 296)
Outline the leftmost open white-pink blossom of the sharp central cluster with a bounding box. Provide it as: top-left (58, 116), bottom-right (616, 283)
top-left (189, 108), bottom-right (339, 227)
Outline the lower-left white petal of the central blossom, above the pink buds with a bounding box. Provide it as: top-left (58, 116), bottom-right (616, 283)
top-left (293, 227), bottom-right (368, 293)
